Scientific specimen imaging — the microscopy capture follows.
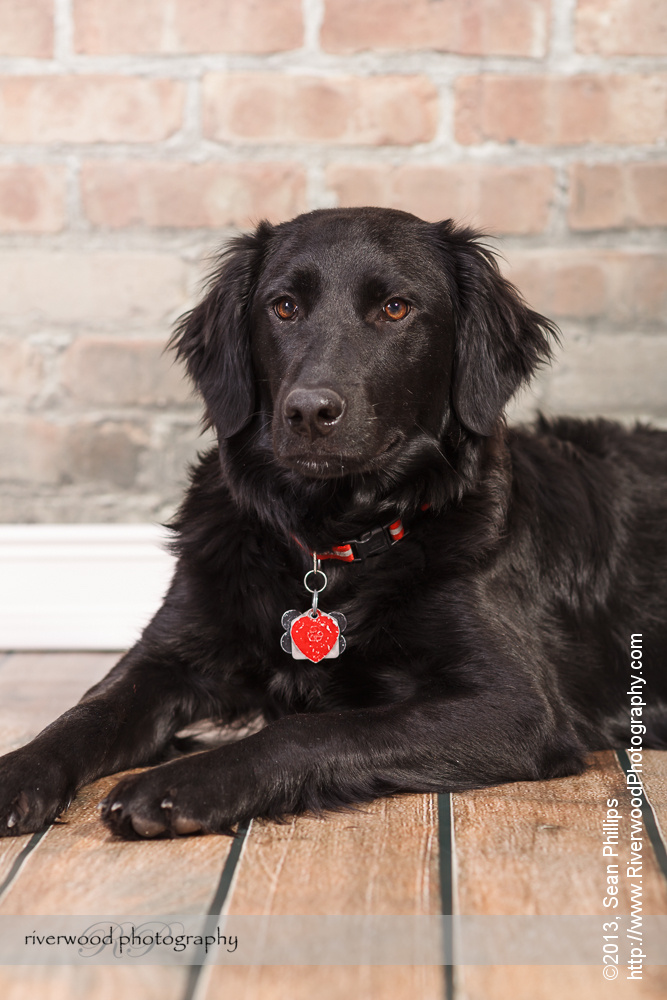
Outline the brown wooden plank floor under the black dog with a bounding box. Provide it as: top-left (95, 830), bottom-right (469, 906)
top-left (0, 653), bottom-right (667, 1000)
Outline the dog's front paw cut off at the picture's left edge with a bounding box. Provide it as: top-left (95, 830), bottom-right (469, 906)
top-left (0, 746), bottom-right (74, 837)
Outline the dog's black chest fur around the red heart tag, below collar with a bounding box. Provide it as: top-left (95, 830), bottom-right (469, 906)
top-left (171, 456), bottom-right (486, 713)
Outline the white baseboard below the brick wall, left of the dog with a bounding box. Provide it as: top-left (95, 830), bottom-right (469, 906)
top-left (0, 524), bottom-right (174, 650)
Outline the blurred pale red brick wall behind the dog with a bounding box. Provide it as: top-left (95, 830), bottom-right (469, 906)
top-left (0, 0), bottom-right (667, 521)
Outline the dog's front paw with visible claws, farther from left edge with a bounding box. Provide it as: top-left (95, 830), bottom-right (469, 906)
top-left (100, 754), bottom-right (233, 840)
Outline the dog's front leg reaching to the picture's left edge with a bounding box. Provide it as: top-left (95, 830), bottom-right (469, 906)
top-left (0, 643), bottom-right (209, 836)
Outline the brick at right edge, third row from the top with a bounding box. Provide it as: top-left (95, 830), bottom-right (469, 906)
top-left (568, 163), bottom-right (667, 230)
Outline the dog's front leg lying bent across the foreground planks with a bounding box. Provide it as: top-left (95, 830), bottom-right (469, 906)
top-left (102, 692), bottom-right (580, 837)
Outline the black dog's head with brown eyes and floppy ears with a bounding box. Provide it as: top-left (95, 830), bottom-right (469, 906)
top-left (175, 208), bottom-right (555, 479)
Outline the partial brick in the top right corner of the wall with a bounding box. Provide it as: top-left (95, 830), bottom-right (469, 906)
top-left (575, 0), bottom-right (667, 56)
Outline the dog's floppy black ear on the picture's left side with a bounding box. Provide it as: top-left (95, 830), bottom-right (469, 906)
top-left (169, 222), bottom-right (273, 438)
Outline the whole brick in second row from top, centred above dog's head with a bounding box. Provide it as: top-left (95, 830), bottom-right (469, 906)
top-left (203, 73), bottom-right (437, 146)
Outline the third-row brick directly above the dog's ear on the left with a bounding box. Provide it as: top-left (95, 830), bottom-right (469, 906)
top-left (81, 160), bottom-right (307, 228)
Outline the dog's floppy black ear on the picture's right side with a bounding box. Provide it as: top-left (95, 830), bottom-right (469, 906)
top-left (435, 219), bottom-right (559, 437)
